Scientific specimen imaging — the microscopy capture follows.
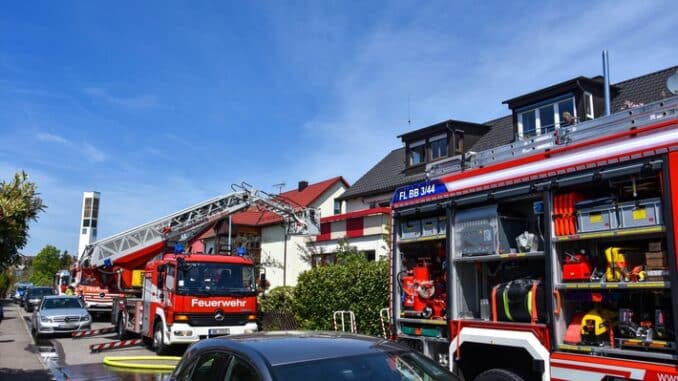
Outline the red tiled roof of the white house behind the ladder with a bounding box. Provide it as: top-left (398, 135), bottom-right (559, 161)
top-left (232, 176), bottom-right (349, 226)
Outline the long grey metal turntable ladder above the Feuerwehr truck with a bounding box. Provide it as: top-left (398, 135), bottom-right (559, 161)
top-left (78, 183), bottom-right (320, 267)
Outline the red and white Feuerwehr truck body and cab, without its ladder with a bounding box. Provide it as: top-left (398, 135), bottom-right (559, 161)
top-left (113, 253), bottom-right (257, 354)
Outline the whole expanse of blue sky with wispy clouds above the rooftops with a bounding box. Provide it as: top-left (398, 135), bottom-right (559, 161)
top-left (0, 1), bottom-right (678, 255)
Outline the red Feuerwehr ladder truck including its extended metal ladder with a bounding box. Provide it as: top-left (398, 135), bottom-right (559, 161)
top-left (78, 183), bottom-right (320, 353)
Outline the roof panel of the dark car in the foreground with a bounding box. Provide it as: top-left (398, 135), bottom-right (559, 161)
top-left (191, 331), bottom-right (408, 366)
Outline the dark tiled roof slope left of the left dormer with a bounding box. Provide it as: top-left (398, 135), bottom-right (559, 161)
top-left (339, 147), bottom-right (424, 200)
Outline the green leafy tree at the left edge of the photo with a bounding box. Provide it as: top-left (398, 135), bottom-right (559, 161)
top-left (0, 171), bottom-right (45, 270)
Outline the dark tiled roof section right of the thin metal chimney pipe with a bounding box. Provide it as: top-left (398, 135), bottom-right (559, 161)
top-left (611, 66), bottom-right (678, 112)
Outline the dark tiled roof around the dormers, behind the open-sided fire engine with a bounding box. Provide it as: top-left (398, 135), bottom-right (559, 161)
top-left (340, 66), bottom-right (678, 200)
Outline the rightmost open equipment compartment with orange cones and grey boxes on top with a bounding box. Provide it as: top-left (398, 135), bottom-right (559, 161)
top-left (551, 162), bottom-right (676, 361)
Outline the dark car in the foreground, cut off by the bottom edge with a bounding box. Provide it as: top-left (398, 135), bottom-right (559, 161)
top-left (171, 332), bottom-right (459, 381)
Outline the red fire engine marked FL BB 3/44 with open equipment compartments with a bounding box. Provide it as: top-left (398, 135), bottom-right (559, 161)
top-left (390, 96), bottom-right (678, 381)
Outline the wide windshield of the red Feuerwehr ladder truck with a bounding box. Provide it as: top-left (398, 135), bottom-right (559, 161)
top-left (177, 263), bottom-right (256, 295)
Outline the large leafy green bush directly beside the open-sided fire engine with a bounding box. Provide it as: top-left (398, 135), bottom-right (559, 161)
top-left (294, 256), bottom-right (389, 336)
